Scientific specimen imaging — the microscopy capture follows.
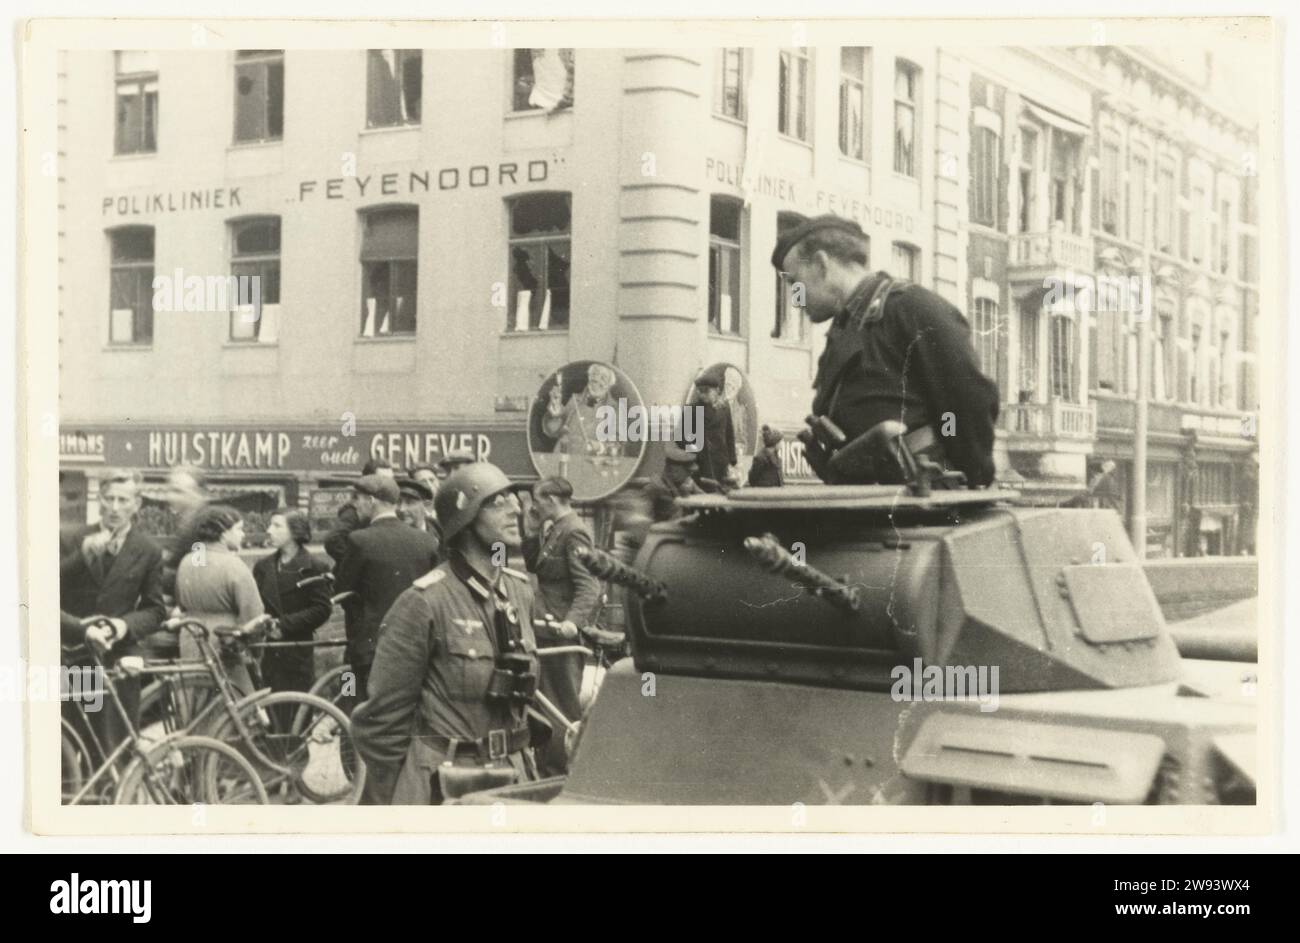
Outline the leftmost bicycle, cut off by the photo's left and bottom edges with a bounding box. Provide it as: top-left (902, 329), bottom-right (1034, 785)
top-left (60, 639), bottom-right (270, 805)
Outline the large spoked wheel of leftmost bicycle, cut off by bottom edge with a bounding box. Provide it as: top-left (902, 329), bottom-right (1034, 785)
top-left (113, 736), bottom-right (270, 805)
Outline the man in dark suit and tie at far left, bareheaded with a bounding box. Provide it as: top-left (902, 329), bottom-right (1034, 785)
top-left (59, 471), bottom-right (166, 750)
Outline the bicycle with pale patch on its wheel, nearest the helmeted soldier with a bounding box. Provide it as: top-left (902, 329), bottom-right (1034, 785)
top-left (144, 617), bottom-right (365, 804)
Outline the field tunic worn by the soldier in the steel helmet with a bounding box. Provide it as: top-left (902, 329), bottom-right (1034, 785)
top-left (352, 553), bottom-right (537, 805)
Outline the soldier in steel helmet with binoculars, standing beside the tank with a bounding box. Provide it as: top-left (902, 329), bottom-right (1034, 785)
top-left (352, 462), bottom-right (537, 805)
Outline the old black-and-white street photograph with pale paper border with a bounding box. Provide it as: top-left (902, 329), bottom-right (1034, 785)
top-left (20, 18), bottom-right (1284, 832)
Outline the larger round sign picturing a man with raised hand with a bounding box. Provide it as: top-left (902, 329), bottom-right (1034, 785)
top-left (528, 360), bottom-right (646, 501)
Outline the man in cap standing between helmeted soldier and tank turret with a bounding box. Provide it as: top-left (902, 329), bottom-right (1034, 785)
top-left (524, 476), bottom-right (601, 777)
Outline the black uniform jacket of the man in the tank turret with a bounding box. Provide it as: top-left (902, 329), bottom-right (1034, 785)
top-left (813, 272), bottom-right (998, 486)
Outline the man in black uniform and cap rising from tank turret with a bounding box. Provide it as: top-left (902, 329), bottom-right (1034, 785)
top-left (772, 216), bottom-right (998, 488)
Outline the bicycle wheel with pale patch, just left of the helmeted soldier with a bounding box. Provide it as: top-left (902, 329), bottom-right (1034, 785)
top-left (212, 691), bottom-right (365, 805)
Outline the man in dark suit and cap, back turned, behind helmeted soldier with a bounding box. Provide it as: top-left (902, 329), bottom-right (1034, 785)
top-left (334, 475), bottom-right (438, 709)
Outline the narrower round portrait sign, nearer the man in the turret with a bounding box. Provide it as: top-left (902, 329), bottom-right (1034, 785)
top-left (685, 363), bottom-right (763, 485)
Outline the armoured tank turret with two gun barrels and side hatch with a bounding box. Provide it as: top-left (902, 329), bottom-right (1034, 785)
top-left (629, 486), bottom-right (1178, 692)
